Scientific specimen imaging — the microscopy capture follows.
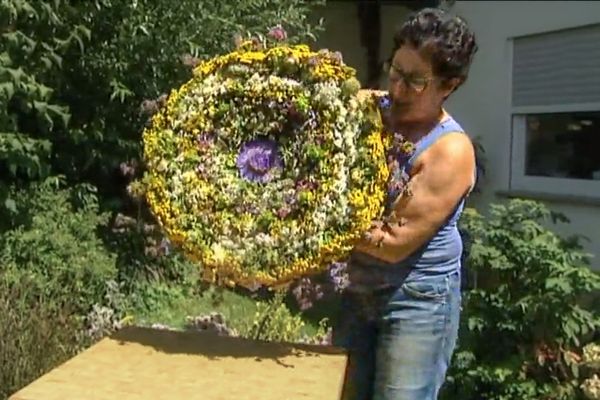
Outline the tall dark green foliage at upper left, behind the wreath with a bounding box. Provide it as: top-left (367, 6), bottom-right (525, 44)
top-left (0, 0), bottom-right (322, 208)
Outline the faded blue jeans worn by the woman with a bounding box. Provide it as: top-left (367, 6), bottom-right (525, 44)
top-left (334, 272), bottom-right (461, 400)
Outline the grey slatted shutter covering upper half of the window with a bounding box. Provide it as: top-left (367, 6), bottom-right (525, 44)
top-left (512, 25), bottom-right (600, 106)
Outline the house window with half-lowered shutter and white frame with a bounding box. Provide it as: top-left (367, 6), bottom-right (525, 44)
top-left (510, 24), bottom-right (600, 198)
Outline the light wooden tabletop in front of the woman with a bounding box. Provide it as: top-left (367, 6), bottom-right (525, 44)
top-left (9, 327), bottom-right (346, 400)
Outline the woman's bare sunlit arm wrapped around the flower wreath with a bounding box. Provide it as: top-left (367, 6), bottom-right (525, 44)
top-left (356, 133), bottom-right (475, 263)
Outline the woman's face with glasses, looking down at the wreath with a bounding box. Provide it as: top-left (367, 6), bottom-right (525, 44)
top-left (388, 45), bottom-right (456, 123)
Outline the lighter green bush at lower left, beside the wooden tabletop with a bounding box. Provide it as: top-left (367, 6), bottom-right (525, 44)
top-left (0, 180), bottom-right (116, 399)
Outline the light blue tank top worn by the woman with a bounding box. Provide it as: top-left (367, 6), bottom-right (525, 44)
top-left (348, 117), bottom-right (465, 289)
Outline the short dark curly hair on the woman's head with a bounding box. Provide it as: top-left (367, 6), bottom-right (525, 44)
top-left (388, 8), bottom-right (477, 86)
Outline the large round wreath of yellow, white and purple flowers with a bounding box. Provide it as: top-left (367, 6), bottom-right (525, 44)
top-left (143, 31), bottom-right (400, 287)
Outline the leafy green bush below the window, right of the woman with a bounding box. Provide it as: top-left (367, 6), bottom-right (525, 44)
top-left (443, 200), bottom-right (600, 400)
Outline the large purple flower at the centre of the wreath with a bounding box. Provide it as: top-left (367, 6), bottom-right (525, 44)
top-left (237, 139), bottom-right (283, 183)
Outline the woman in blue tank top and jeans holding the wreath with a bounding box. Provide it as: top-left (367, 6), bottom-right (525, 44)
top-left (334, 9), bottom-right (477, 400)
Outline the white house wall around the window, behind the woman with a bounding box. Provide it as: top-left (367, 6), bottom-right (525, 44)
top-left (448, 1), bottom-right (600, 269)
